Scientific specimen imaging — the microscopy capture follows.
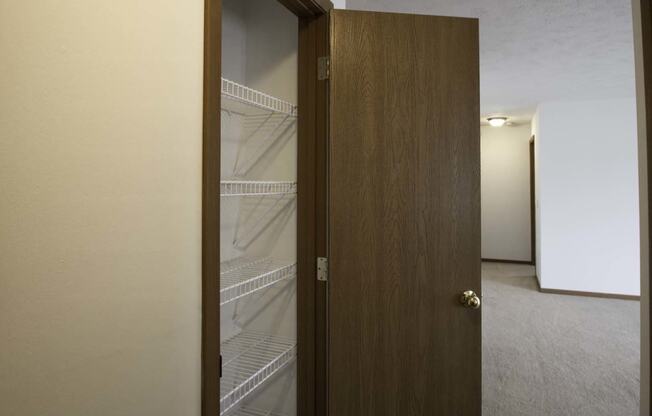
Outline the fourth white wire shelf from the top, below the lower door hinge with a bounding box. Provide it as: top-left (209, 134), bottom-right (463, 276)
top-left (220, 331), bottom-right (297, 415)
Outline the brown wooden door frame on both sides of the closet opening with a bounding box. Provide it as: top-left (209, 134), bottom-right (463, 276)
top-left (201, 0), bottom-right (333, 416)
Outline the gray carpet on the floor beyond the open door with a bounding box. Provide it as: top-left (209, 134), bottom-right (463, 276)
top-left (482, 263), bottom-right (640, 416)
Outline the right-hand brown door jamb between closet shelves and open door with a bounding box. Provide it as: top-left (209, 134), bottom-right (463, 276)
top-left (298, 7), bottom-right (332, 416)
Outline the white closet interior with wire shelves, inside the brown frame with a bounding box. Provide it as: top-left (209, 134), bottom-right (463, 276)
top-left (219, 0), bottom-right (299, 416)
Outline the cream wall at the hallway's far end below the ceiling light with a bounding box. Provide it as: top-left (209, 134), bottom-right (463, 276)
top-left (481, 124), bottom-right (532, 261)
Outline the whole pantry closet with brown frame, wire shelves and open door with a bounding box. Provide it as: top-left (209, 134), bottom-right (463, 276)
top-left (202, 0), bottom-right (480, 416)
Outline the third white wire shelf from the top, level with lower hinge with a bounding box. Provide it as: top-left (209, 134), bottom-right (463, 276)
top-left (220, 257), bottom-right (297, 306)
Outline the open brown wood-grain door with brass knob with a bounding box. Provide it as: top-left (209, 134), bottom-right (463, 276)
top-left (328, 10), bottom-right (481, 416)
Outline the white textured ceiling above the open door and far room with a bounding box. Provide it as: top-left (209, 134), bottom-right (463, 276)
top-left (346, 0), bottom-right (635, 120)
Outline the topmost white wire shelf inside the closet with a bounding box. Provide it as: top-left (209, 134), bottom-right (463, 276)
top-left (222, 78), bottom-right (298, 117)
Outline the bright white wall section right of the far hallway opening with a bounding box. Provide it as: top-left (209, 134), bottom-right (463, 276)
top-left (536, 98), bottom-right (640, 295)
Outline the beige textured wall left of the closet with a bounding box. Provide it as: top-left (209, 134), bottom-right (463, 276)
top-left (0, 0), bottom-right (203, 416)
